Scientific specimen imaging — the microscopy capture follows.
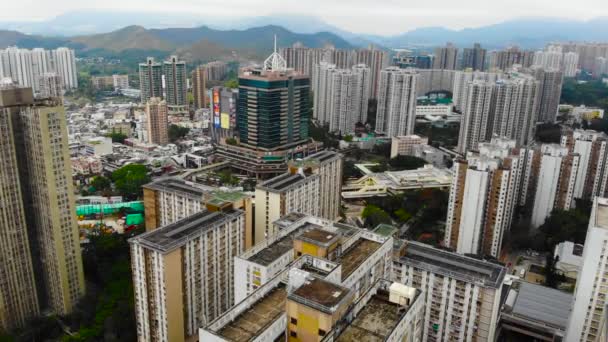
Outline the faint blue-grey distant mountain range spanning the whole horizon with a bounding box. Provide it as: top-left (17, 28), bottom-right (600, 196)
top-left (0, 11), bottom-right (608, 48)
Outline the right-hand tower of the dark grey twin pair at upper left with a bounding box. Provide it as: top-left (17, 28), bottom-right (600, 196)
top-left (163, 56), bottom-right (188, 107)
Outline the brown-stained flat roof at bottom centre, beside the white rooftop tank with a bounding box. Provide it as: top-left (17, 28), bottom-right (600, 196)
top-left (335, 291), bottom-right (405, 342)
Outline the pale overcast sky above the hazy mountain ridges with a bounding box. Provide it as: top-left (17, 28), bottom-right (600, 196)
top-left (0, 0), bottom-right (608, 34)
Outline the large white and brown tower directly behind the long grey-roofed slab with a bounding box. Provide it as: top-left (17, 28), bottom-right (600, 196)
top-left (444, 138), bottom-right (524, 257)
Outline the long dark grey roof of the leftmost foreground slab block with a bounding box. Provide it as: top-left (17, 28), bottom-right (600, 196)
top-left (130, 210), bottom-right (242, 253)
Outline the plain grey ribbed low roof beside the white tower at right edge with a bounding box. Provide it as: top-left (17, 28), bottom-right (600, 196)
top-left (512, 282), bottom-right (573, 330)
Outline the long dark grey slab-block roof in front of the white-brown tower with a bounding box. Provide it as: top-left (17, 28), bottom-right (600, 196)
top-left (402, 241), bottom-right (506, 288)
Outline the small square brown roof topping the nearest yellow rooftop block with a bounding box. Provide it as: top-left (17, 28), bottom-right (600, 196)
top-left (288, 277), bottom-right (350, 314)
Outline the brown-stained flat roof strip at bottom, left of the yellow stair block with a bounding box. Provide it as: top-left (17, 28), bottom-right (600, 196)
top-left (217, 283), bottom-right (287, 342)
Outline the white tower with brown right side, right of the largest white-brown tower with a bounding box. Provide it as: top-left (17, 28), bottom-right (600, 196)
top-left (529, 144), bottom-right (580, 228)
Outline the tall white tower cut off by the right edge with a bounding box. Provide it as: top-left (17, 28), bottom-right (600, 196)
top-left (564, 197), bottom-right (608, 342)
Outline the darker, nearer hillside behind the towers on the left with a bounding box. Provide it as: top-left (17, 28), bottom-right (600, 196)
top-left (0, 26), bottom-right (353, 61)
